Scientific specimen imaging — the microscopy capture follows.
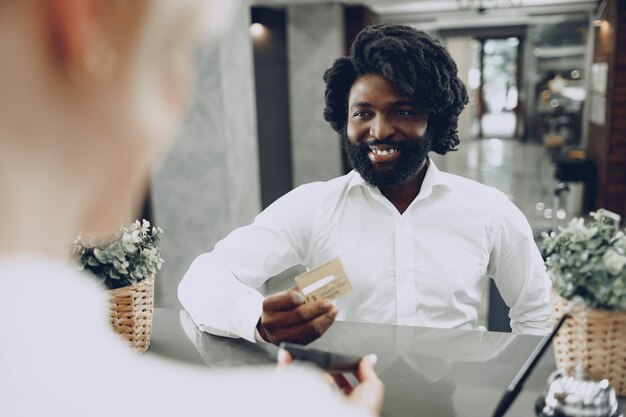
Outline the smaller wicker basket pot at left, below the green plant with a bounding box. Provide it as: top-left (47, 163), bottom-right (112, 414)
top-left (109, 278), bottom-right (154, 352)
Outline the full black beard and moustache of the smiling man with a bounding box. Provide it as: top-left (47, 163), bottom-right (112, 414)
top-left (341, 129), bottom-right (432, 188)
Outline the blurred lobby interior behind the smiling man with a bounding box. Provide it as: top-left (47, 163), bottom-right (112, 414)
top-left (144, 0), bottom-right (626, 330)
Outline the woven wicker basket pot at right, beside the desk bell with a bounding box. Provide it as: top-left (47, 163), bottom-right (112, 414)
top-left (551, 291), bottom-right (626, 396)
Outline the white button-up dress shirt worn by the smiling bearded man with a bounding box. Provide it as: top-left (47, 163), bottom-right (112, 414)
top-left (179, 161), bottom-right (550, 341)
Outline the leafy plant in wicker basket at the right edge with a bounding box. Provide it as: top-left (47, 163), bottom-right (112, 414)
top-left (543, 209), bottom-right (626, 395)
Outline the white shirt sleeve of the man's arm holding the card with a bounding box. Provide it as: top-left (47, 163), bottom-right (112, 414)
top-left (178, 184), bottom-right (316, 342)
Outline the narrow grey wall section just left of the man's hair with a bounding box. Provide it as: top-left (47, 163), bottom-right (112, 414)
top-left (287, 3), bottom-right (344, 187)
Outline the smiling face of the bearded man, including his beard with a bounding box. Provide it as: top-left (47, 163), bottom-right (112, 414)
top-left (342, 73), bottom-right (431, 187)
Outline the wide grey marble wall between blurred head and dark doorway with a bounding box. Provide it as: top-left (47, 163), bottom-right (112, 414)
top-left (152, 5), bottom-right (260, 307)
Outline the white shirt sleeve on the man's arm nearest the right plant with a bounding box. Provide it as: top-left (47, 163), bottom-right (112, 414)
top-left (488, 196), bottom-right (551, 334)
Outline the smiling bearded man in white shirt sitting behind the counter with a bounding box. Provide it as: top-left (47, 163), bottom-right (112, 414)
top-left (179, 24), bottom-right (550, 343)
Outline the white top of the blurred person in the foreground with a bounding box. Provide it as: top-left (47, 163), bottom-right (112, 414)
top-left (0, 257), bottom-right (365, 417)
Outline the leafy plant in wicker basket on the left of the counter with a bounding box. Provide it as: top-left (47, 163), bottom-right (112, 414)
top-left (74, 220), bottom-right (163, 352)
